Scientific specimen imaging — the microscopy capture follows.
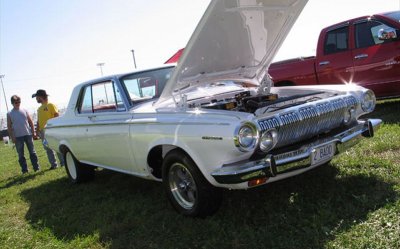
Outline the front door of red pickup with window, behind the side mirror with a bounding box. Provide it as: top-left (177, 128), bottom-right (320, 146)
top-left (353, 19), bottom-right (400, 97)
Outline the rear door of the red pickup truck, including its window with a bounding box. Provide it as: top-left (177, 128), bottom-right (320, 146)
top-left (315, 25), bottom-right (353, 84)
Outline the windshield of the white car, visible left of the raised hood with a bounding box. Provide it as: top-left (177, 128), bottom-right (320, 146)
top-left (121, 67), bottom-right (174, 105)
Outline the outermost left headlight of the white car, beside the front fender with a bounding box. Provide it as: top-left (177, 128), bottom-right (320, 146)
top-left (235, 123), bottom-right (258, 152)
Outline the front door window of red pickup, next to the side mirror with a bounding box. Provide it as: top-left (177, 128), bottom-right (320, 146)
top-left (354, 21), bottom-right (390, 48)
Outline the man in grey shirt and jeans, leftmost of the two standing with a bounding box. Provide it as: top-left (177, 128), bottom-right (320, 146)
top-left (7, 95), bottom-right (40, 174)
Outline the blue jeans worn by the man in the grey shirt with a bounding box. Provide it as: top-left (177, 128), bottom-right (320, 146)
top-left (15, 135), bottom-right (40, 173)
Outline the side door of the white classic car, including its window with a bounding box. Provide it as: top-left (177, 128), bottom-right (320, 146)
top-left (80, 81), bottom-right (138, 172)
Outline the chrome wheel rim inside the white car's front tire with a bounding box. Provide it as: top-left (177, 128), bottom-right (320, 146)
top-left (168, 163), bottom-right (197, 209)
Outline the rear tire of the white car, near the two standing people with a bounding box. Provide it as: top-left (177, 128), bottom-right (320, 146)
top-left (64, 150), bottom-right (94, 183)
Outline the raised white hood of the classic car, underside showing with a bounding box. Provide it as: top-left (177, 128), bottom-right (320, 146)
top-left (158, 0), bottom-right (308, 104)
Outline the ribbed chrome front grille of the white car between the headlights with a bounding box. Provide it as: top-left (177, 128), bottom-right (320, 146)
top-left (257, 95), bottom-right (359, 148)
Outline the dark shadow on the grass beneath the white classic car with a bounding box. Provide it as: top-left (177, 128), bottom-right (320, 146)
top-left (22, 165), bottom-right (398, 248)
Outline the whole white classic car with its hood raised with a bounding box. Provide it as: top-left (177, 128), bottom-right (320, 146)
top-left (45, 0), bottom-right (381, 216)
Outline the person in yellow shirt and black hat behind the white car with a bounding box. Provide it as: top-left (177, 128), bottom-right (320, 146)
top-left (32, 89), bottom-right (64, 169)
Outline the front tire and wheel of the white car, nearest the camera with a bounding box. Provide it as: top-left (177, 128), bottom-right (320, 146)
top-left (162, 150), bottom-right (222, 217)
